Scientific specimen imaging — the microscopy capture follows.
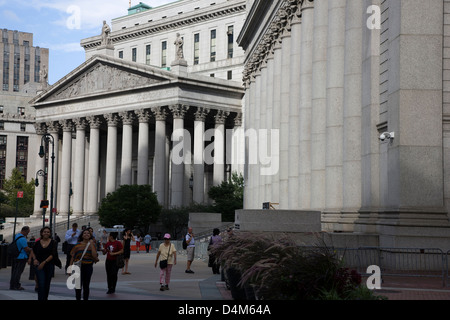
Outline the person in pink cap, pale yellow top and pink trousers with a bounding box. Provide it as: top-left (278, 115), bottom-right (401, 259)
top-left (155, 233), bottom-right (177, 291)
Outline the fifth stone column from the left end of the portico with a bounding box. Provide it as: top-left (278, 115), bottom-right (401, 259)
top-left (86, 116), bottom-right (101, 215)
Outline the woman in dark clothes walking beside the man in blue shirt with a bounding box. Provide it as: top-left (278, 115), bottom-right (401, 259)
top-left (33, 227), bottom-right (62, 301)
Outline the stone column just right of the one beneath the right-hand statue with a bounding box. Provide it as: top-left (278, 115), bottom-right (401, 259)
top-left (192, 108), bottom-right (210, 203)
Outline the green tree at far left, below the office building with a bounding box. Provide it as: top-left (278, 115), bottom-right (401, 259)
top-left (0, 168), bottom-right (35, 217)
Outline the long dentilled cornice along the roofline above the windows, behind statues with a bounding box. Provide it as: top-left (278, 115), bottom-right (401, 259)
top-left (81, 1), bottom-right (246, 50)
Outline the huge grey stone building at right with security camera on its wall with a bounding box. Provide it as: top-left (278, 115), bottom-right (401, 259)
top-left (238, 0), bottom-right (450, 249)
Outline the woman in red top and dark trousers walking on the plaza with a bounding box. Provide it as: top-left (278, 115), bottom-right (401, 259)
top-left (103, 232), bottom-right (123, 294)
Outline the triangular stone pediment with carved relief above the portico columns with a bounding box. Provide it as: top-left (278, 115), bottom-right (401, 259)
top-left (32, 56), bottom-right (176, 104)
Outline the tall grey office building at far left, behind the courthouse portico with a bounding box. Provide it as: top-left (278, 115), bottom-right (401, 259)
top-left (0, 29), bottom-right (49, 189)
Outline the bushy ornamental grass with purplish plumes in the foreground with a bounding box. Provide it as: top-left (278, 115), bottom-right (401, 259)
top-left (211, 232), bottom-right (380, 300)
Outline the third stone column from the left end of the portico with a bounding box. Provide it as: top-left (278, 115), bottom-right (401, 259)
top-left (59, 120), bottom-right (73, 216)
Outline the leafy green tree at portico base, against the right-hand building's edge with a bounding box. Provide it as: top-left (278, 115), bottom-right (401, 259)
top-left (208, 172), bottom-right (244, 221)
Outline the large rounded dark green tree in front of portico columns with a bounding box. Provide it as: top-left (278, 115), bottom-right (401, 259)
top-left (98, 185), bottom-right (162, 231)
